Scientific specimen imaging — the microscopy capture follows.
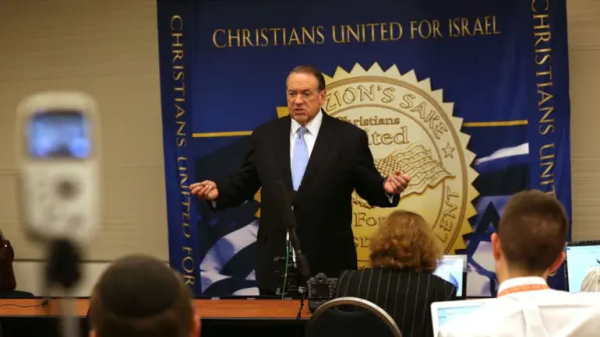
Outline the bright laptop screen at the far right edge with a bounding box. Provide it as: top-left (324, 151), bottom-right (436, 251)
top-left (565, 241), bottom-right (600, 293)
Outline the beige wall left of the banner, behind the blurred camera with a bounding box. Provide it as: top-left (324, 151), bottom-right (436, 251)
top-left (0, 0), bottom-right (168, 260)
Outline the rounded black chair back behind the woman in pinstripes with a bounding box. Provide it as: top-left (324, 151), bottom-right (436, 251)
top-left (305, 297), bottom-right (402, 337)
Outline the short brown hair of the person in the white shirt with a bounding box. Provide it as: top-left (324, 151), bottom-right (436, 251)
top-left (497, 190), bottom-right (569, 273)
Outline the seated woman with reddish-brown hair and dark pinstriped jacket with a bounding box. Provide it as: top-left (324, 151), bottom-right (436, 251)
top-left (336, 210), bottom-right (456, 337)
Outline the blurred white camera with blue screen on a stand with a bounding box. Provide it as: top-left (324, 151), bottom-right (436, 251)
top-left (16, 92), bottom-right (101, 336)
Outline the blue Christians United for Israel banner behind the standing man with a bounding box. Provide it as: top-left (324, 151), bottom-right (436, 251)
top-left (158, 0), bottom-right (571, 296)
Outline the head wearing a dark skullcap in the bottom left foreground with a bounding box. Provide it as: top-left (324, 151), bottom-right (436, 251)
top-left (89, 256), bottom-right (200, 337)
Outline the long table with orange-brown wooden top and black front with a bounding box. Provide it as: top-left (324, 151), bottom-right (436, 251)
top-left (0, 298), bottom-right (310, 337)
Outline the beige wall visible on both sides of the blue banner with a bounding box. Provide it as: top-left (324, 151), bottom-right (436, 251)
top-left (0, 0), bottom-right (600, 295)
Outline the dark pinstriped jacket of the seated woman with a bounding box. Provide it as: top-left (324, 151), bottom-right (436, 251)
top-left (336, 268), bottom-right (456, 337)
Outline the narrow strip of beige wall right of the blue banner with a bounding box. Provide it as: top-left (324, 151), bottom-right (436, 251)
top-left (567, 0), bottom-right (600, 240)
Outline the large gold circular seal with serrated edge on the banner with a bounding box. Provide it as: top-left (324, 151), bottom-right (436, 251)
top-left (324, 64), bottom-right (477, 267)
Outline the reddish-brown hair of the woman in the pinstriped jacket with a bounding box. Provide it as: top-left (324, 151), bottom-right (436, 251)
top-left (370, 210), bottom-right (443, 272)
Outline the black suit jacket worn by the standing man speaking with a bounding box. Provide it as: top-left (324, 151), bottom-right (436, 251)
top-left (211, 112), bottom-right (400, 292)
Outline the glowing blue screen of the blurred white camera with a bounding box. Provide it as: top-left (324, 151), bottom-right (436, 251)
top-left (27, 111), bottom-right (91, 159)
